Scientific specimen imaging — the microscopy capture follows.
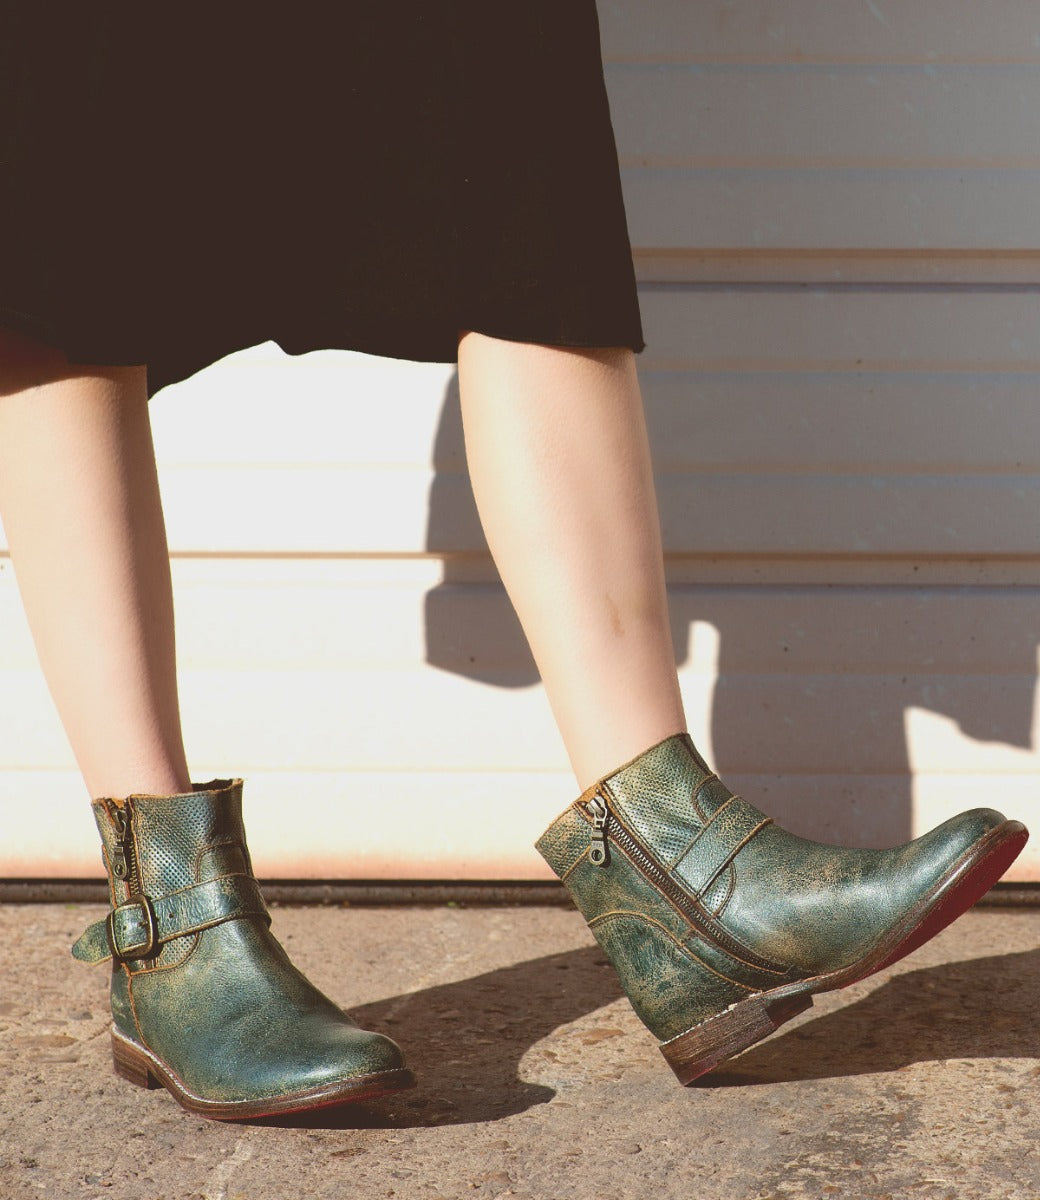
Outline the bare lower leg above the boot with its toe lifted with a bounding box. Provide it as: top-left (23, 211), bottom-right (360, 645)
top-left (458, 332), bottom-right (686, 788)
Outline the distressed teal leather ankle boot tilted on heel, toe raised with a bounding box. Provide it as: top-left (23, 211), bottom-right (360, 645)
top-left (537, 734), bottom-right (1028, 1084)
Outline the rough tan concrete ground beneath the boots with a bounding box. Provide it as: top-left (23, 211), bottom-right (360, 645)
top-left (0, 905), bottom-right (1040, 1200)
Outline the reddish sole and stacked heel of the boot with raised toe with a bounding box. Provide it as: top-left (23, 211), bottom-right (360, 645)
top-left (661, 821), bottom-right (1029, 1086)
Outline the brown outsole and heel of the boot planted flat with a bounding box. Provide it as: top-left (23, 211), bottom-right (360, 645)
top-left (112, 1030), bottom-right (415, 1121)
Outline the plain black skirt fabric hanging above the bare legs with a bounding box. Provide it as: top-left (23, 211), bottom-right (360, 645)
top-left (0, 0), bottom-right (643, 391)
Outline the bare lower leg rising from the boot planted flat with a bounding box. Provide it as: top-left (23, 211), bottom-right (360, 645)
top-left (0, 332), bottom-right (191, 797)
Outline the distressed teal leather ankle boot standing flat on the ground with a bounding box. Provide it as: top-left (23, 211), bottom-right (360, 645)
top-left (72, 779), bottom-right (414, 1120)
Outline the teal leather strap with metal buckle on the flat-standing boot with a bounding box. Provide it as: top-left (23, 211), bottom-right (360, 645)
top-left (72, 875), bottom-right (271, 962)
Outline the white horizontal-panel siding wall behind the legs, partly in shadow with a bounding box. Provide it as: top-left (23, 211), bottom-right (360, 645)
top-left (0, 0), bottom-right (1040, 878)
